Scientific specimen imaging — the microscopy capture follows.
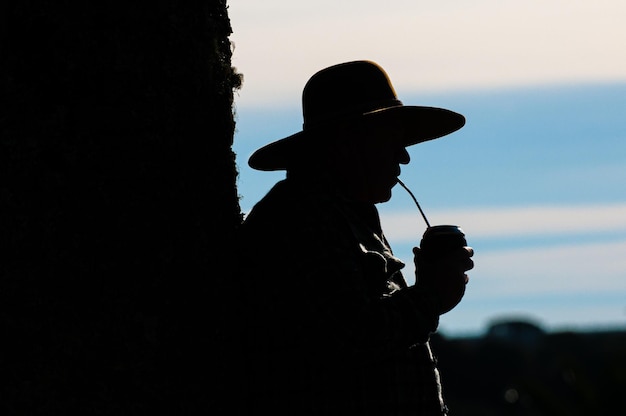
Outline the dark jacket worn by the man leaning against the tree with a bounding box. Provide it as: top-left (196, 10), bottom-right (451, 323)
top-left (238, 178), bottom-right (446, 415)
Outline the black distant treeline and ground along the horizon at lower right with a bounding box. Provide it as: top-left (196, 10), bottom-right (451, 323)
top-left (433, 322), bottom-right (626, 416)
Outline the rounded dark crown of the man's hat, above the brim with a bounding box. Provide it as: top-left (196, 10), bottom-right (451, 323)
top-left (302, 61), bottom-right (402, 130)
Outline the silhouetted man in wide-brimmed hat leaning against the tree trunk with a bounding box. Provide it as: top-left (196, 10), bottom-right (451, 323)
top-left (239, 61), bottom-right (473, 415)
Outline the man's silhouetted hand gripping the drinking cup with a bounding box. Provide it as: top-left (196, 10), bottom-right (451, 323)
top-left (413, 247), bottom-right (474, 315)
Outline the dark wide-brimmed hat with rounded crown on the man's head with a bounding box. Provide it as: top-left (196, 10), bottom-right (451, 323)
top-left (248, 61), bottom-right (465, 171)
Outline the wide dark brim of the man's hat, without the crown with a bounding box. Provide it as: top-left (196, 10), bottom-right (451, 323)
top-left (248, 106), bottom-right (465, 171)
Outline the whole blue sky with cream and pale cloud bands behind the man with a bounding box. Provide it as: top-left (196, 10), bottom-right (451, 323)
top-left (229, 0), bottom-right (626, 336)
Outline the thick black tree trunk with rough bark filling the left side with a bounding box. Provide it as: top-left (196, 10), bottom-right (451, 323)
top-left (0, 0), bottom-right (241, 415)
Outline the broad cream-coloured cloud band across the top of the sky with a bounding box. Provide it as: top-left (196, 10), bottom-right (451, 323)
top-left (229, 0), bottom-right (626, 102)
